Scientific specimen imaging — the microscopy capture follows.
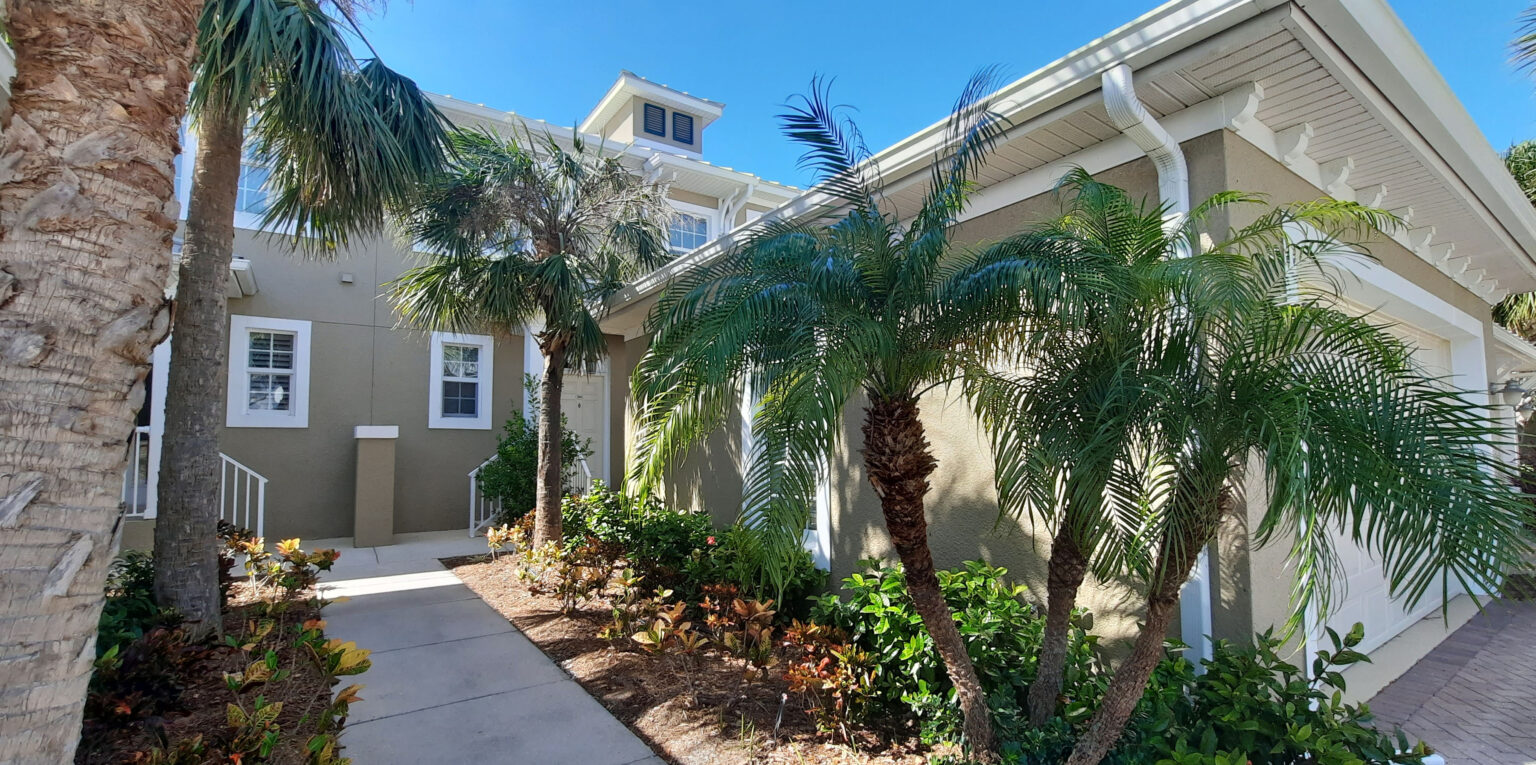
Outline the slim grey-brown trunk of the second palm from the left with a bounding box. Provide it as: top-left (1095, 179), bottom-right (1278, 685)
top-left (155, 102), bottom-right (246, 639)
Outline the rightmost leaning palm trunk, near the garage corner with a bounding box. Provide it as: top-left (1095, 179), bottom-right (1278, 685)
top-left (1066, 488), bottom-right (1235, 765)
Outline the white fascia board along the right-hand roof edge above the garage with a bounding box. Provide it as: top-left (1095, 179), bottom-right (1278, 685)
top-left (1289, 0), bottom-right (1536, 288)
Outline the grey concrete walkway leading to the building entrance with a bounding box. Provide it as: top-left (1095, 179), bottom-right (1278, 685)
top-left (307, 532), bottom-right (662, 765)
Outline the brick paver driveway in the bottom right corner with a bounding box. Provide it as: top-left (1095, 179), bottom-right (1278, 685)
top-left (1370, 601), bottom-right (1536, 765)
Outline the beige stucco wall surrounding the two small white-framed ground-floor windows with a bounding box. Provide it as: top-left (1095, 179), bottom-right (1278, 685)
top-left (220, 230), bottom-right (522, 538)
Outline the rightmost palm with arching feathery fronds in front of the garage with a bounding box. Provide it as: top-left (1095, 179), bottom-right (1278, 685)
top-left (1032, 180), bottom-right (1530, 765)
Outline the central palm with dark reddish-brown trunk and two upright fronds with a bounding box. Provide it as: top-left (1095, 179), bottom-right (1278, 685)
top-left (631, 72), bottom-right (1094, 760)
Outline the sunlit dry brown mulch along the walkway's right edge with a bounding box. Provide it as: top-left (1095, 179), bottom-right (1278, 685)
top-left (442, 555), bottom-right (935, 765)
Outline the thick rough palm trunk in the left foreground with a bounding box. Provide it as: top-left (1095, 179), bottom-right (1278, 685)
top-left (0, 0), bottom-right (201, 763)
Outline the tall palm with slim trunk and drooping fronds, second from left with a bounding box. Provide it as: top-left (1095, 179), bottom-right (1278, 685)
top-left (155, 0), bottom-right (444, 634)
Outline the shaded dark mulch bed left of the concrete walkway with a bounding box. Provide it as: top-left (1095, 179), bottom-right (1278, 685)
top-left (75, 582), bottom-right (332, 765)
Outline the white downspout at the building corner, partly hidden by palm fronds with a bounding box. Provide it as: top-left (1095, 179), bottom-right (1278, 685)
top-left (1103, 65), bottom-right (1212, 670)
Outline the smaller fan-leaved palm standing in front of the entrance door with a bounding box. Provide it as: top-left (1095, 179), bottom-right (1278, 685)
top-left (387, 123), bottom-right (673, 545)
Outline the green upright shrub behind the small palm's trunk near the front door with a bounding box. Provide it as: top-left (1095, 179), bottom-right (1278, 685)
top-left (479, 375), bottom-right (591, 524)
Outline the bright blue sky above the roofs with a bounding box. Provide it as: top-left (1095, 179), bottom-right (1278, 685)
top-left (366, 0), bottom-right (1536, 186)
